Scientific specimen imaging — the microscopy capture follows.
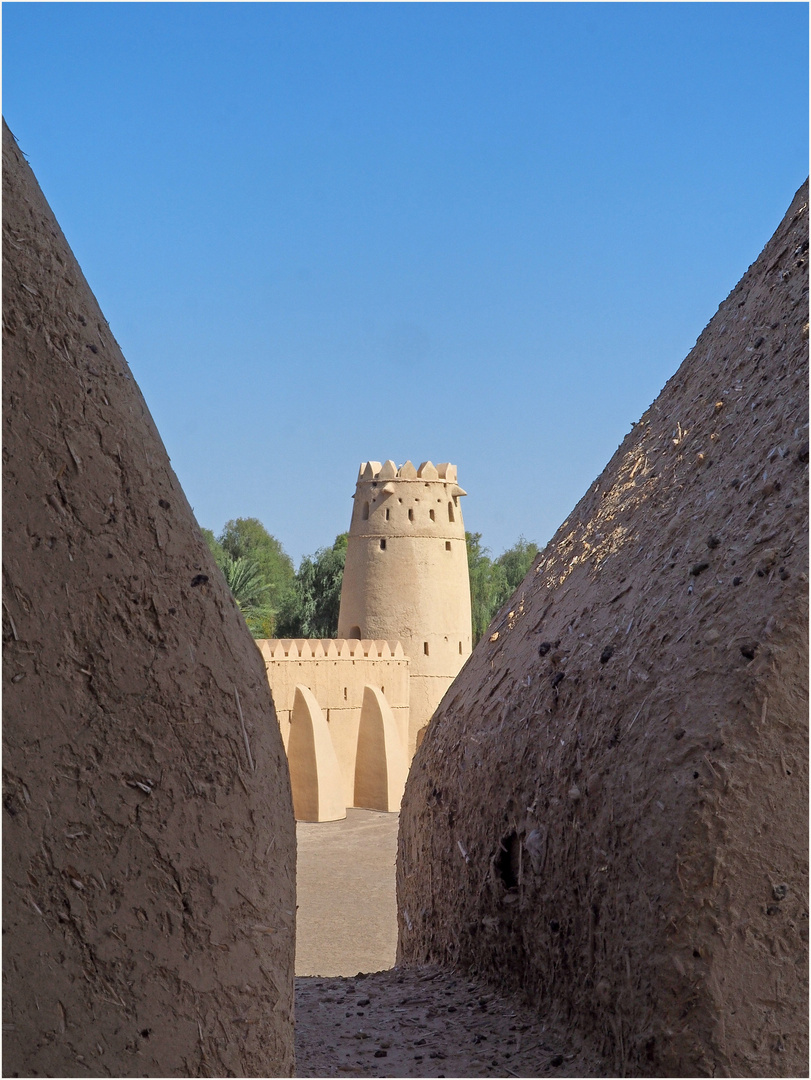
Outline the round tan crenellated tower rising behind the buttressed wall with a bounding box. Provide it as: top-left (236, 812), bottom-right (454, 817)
top-left (338, 461), bottom-right (472, 760)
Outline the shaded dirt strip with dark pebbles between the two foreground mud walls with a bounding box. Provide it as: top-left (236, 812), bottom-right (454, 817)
top-left (296, 968), bottom-right (600, 1077)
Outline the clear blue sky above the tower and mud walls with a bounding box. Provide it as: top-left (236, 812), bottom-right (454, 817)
top-left (2, 3), bottom-right (809, 563)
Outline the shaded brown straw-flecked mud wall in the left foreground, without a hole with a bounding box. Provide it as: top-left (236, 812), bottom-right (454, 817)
top-left (2, 122), bottom-right (295, 1077)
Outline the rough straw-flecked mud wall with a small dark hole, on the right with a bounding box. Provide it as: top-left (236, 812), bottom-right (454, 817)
top-left (397, 186), bottom-right (809, 1076)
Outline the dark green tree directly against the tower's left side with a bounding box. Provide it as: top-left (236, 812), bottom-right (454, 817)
top-left (279, 532), bottom-right (348, 637)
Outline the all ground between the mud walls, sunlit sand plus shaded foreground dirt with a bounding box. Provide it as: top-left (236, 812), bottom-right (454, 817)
top-left (296, 810), bottom-right (600, 1077)
